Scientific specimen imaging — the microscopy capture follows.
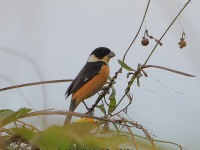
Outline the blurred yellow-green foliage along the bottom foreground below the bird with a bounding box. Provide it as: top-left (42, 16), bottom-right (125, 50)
top-left (0, 108), bottom-right (183, 150)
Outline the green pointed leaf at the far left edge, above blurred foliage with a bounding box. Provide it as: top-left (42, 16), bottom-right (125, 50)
top-left (0, 108), bottom-right (31, 127)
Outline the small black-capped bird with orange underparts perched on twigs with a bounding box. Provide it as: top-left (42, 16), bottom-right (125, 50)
top-left (64, 47), bottom-right (115, 126)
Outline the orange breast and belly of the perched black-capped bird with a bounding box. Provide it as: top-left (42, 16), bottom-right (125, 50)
top-left (72, 65), bottom-right (110, 106)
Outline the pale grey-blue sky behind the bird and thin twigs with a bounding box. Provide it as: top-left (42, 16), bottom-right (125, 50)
top-left (0, 0), bottom-right (200, 150)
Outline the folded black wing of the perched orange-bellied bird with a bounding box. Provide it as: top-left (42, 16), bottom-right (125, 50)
top-left (65, 61), bottom-right (104, 98)
